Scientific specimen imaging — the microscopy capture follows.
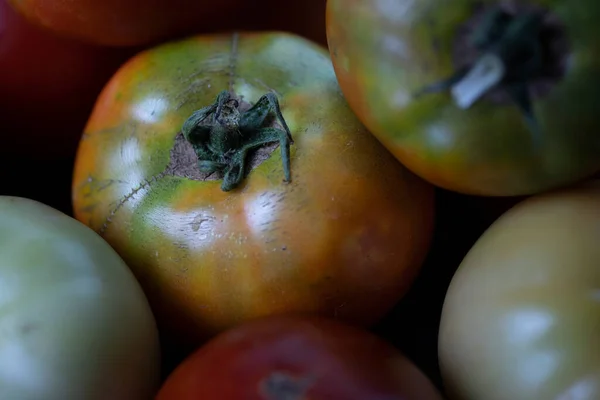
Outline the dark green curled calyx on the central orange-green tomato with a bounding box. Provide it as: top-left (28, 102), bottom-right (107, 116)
top-left (182, 90), bottom-right (294, 192)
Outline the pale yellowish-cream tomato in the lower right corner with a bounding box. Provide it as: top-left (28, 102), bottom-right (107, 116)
top-left (439, 181), bottom-right (600, 400)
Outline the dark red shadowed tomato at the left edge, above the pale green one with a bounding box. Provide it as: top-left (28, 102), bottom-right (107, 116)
top-left (0, 0), bottom-right (130, 160)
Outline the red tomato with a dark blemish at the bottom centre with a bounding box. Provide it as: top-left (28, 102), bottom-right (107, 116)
top-left (156, 316), bottom-right (442, 400)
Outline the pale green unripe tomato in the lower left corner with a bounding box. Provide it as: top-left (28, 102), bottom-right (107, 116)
top-left (0, 196), bottom-right (160, 400)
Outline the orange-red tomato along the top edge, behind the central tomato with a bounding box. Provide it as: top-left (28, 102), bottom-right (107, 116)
top-left (8, 0), bottom-right (326, 46)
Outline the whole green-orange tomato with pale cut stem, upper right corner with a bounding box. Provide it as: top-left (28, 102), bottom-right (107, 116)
top-left (327, 0), bottom-right (600, 196)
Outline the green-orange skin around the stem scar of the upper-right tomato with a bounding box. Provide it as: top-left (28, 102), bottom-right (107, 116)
top-left (327, 0), bottom-right (600, 196)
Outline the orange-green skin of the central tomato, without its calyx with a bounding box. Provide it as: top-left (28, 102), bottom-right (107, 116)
top-left (73, 33), bottom-right (433, 340)
